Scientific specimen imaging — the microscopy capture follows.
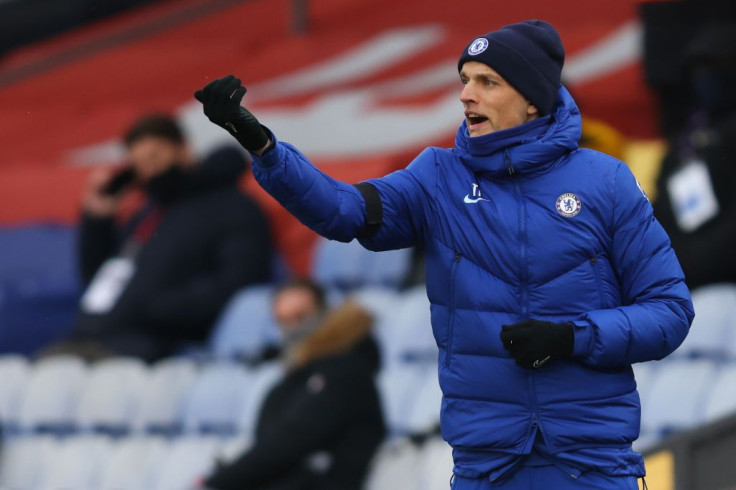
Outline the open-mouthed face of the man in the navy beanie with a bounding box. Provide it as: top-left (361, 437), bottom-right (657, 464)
top-left (460, 61), bottom-right (538, 136)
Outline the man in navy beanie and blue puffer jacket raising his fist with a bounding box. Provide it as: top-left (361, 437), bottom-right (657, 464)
top-left (195, 20), bottom-right (693, 490)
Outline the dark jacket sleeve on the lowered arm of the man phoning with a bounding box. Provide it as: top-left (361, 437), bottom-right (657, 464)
top-left (142, 202), bottom-right (272, 337)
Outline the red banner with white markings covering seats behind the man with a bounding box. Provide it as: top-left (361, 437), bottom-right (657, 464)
top-left (0, 0), bottom-right (656, 272)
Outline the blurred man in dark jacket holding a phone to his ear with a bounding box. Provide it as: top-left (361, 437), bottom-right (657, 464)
top-left (42, 114), bottom-right (272, 361)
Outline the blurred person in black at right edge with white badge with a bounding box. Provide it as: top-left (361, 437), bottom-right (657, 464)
top-left (654, 21), bottom-right (736, 287)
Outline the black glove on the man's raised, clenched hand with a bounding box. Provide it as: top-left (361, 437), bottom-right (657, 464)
top-left (194, 75), bottom-right (268, 152)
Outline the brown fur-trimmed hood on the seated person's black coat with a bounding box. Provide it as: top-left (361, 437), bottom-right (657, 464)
top-left (287, 302), bottom-right (378, 372)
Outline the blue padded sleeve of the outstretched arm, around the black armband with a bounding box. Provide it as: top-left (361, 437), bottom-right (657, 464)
top-left (253, 128), bottom-right (433, 250)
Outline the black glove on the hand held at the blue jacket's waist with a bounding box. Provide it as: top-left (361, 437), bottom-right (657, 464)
top-left (501, 318), bottom-right (575, 369)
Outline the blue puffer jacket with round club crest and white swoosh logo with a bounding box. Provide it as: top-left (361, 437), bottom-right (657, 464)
top-left (253, 88), bottom-right (693, 478)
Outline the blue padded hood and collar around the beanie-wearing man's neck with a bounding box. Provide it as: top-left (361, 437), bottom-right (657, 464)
top-left (455, 86), bottom-right (581, 176)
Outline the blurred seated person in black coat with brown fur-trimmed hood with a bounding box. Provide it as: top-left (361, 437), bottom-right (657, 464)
top-left (205, 280), bottom-right (385, 490)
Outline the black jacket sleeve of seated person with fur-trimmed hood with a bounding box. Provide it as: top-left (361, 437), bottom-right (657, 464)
top-left (206, 368), bottom-right (364, 490)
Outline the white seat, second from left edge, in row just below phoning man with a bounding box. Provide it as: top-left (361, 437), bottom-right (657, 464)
top-left (18, 356), bottom-right (87, 431)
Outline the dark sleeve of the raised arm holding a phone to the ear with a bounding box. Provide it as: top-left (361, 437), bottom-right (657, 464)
top-left (79, 213), bottom-right (118, 284)
